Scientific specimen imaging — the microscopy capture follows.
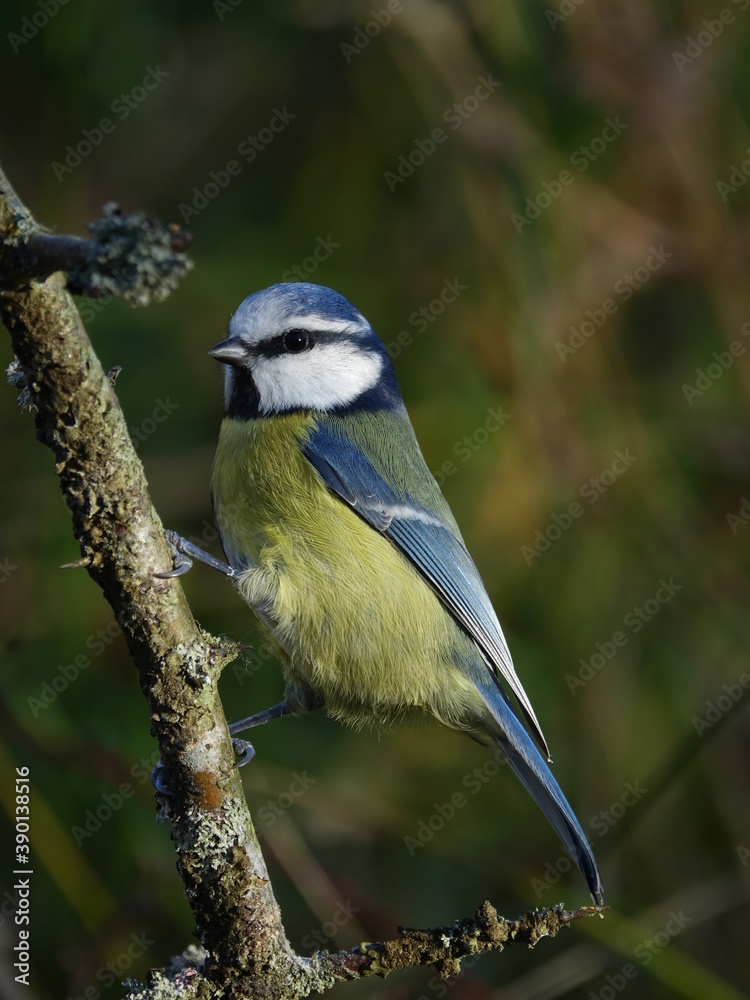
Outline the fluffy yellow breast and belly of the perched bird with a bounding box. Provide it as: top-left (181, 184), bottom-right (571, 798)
top-left (212, 414), bottom-right (483, 729)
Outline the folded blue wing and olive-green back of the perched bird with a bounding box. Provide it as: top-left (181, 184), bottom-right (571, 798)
top-left (302, 411), bottom-right (549, 758)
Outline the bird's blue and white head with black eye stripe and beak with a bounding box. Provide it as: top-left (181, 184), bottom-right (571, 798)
top-left (209, 282), bottom-right (403, 420)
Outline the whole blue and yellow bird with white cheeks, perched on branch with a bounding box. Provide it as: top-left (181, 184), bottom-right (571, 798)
top-left (161, 282), bottom-right (603, 906)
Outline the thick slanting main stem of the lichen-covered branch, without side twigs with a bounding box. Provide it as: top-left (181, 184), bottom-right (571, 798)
top-left (0, 166), bottom-right (302, 995)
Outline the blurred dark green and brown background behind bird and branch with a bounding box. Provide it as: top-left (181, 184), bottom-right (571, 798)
top-left (0, 0), bottom-right (750, 1000)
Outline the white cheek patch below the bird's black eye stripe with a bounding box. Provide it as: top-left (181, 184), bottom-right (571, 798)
top-left (253, 340), bottom-right (383, 413)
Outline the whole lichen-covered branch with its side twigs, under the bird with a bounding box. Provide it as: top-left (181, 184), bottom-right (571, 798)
top-left (0, 171), bottom-right (596, 1000)
